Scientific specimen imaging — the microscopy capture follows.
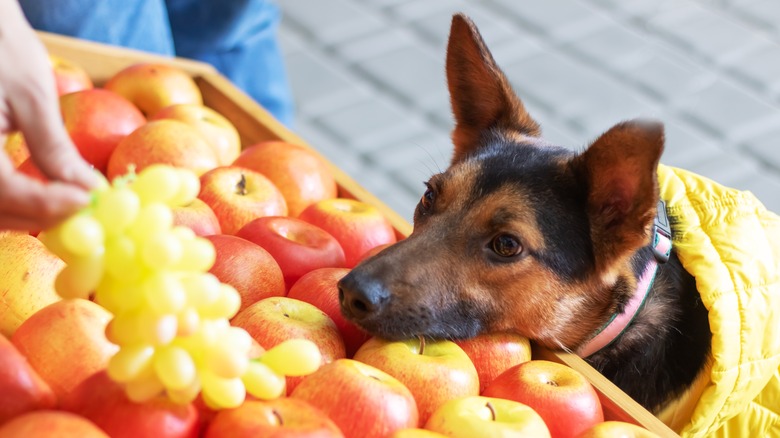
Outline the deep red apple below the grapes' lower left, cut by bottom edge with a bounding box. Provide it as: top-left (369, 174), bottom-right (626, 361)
top-left (62, 370), bottom-right (200, 438)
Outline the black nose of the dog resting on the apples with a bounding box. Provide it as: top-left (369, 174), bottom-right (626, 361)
top-left (338, 270), bottom-right (390, 320)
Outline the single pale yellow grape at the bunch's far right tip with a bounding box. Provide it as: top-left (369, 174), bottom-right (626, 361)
top-left (260, 339), bottom-right (322, 376)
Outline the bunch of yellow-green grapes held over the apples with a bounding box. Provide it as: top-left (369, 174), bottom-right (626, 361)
top-left (40, 165), bottom-right (320, 409)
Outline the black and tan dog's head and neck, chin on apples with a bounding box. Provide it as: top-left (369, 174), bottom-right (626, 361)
top-left (339, 15), bottom-right (710, 411)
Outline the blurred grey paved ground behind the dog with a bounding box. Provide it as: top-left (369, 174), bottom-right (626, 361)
top-left (279, 0), bottom-right (780, 218)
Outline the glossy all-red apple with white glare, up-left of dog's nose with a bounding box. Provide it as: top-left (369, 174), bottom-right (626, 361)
top-left (236, 216), bottom-right (345, 287)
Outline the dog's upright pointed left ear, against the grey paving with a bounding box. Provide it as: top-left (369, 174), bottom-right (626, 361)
top-left (447, 14), bottom-right (540, 163)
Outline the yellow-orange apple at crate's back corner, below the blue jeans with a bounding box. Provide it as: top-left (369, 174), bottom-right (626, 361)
top-left (104, 62), bottom-right (203, 116)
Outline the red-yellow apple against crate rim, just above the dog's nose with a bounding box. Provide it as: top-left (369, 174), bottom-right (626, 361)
top-left (298, 198), bottom-right (396, 268)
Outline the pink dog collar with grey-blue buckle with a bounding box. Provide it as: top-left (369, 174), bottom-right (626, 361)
top-left (577, 201), bottom-right (672, 357)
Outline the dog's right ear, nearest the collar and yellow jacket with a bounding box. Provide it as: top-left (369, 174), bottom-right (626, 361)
top-left (573, 120), bottom-right (664, 275)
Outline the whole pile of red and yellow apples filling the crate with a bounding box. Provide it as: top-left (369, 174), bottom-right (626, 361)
top-left (0, 57), bottom-right (655, 438)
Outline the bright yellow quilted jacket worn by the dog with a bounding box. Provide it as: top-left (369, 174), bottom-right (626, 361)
top-left (658, 165), bottom-right (780, 438)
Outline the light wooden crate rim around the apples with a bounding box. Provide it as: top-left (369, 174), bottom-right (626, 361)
top-left (39, 32), bottom-right (678, 437)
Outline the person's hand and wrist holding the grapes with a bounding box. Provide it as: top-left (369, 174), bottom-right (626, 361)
top-left (0, 0), bottom-right (97, 230)
